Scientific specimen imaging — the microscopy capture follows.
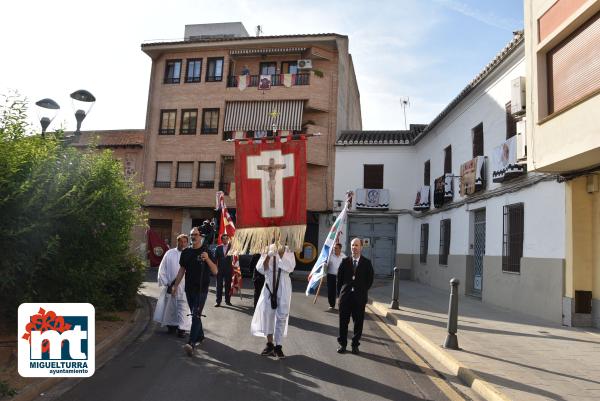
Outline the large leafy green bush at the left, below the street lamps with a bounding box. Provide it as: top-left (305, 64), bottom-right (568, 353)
top-left (0, 91), bottom-right (143, 320)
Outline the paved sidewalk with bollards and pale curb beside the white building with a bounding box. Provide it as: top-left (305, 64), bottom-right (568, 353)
top-left (369, 281), bottom-right (600, 401)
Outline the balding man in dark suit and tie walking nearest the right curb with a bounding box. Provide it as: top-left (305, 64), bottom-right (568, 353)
top-left (337, 238), bottom-right (374, 354)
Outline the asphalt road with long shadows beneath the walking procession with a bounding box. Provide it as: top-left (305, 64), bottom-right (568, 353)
top-left (46, 273), bottom-right (466, 401)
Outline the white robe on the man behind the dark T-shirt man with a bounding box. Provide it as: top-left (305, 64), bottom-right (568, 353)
top-left (154, 248), bottom-right (192, 330)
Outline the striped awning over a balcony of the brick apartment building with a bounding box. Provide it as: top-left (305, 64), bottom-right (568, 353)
top-left (223, 100), bottom-right (304, 131)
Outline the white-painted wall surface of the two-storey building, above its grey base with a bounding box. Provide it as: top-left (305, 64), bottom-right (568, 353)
top-left (334, 47), bottom-right (565, 259)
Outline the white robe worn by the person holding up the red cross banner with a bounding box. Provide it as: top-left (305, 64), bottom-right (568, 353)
top-left (250, 247), bottom-right (296, 345)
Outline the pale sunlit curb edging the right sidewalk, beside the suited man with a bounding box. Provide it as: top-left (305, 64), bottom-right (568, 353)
top-left (369, 298), bottom-right (511, 401)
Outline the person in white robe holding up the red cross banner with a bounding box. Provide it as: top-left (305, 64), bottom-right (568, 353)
top-left (250, 244), bottom-right (296, 359)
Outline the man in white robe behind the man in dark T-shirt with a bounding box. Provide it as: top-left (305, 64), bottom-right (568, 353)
top-left (154, 234), bottom-right (192, 338)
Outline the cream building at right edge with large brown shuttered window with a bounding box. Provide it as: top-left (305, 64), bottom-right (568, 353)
top-left (525, 0), bottom-right (600, 327)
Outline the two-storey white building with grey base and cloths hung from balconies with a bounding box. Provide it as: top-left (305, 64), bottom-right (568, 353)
top-left (334, 32), bottom-right (565, 323)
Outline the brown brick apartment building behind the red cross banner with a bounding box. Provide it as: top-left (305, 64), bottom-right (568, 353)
top-left (142, 23), bottom-right (361, 268)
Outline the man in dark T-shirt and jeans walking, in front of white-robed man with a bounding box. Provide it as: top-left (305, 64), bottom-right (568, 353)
top-left (172, 227), bottom-right (218, 356)
